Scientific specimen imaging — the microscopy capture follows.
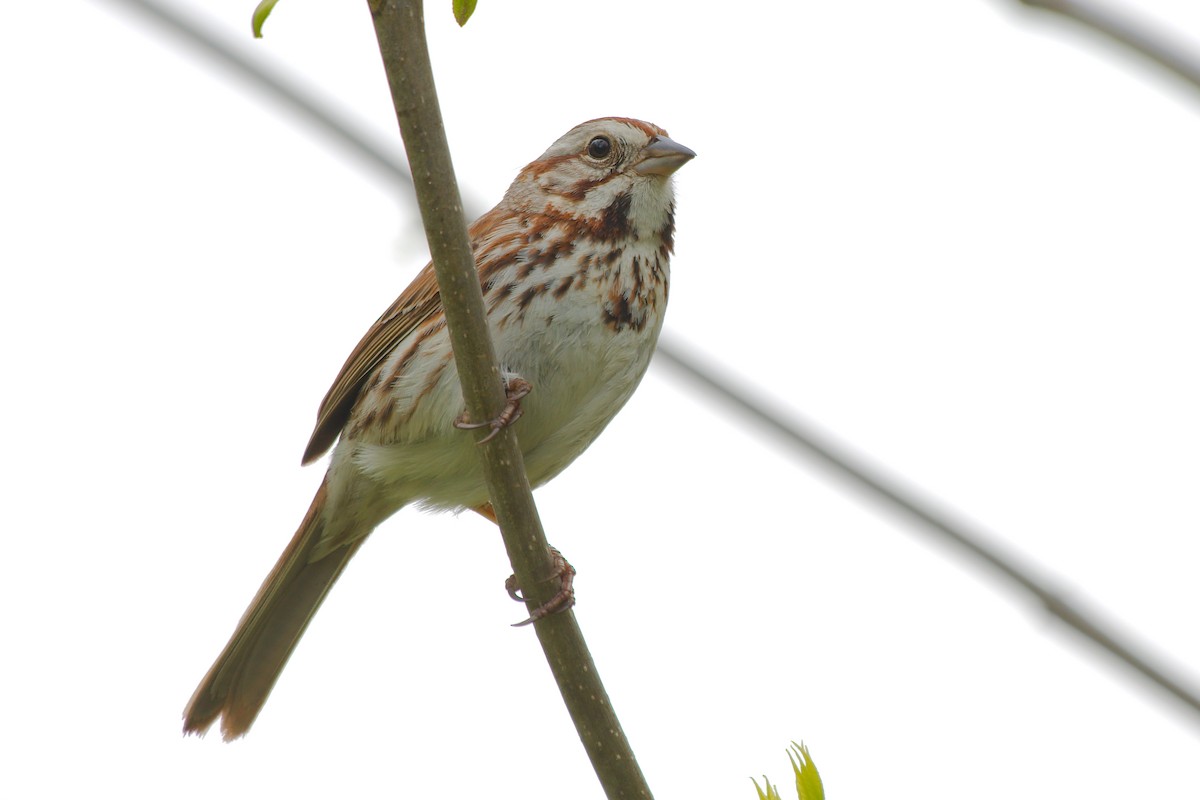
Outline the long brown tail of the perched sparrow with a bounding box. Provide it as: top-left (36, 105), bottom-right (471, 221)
top-left (184, 482), bottom-right (365, 741)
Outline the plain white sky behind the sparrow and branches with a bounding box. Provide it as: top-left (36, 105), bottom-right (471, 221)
top-left (0, 0), bottom-right (1200, 799)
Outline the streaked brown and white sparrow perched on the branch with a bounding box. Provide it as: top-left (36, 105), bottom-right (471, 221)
top-left (184, 118), bottom-right (695, 740)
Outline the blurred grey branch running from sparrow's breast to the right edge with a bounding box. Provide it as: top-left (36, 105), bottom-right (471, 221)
top-left (656, 343), bottom-right (1200, 712)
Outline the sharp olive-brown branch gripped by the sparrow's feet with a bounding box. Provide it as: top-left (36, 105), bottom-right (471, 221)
top-left (368, 0), bottom-right (652, 799)
